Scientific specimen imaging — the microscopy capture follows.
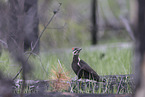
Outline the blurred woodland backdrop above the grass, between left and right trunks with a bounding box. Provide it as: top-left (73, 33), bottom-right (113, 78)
top-left (38, 0), bottom-right (132, 50)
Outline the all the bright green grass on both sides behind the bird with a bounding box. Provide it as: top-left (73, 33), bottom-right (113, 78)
top-left (0, 48), bottom-right (132, 80)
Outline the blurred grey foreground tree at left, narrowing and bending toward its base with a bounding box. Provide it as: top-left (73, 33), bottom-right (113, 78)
top-left (7, 0), bottom-right (30, 96)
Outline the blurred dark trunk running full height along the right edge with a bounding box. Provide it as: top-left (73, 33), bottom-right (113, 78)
top-left (134, 0), bottom-right (145, 97)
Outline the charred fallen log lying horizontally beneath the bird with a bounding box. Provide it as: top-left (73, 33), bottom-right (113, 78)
top-left (14, 75), bottom-right (134, 94)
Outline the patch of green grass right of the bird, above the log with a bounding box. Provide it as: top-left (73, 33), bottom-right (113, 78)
top-left (80, 49), bottom-right (131, 75)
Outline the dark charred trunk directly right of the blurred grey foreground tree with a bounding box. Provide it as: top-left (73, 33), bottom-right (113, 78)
top-left (24, 0), bottom-right (39, 54)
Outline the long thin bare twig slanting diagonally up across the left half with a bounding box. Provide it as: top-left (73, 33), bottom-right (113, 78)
top-left (13, 3), bottom-right (61, 80)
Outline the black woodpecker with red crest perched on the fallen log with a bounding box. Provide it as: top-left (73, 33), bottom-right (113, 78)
top-left (71, 47), bottom-right (100, 81)
